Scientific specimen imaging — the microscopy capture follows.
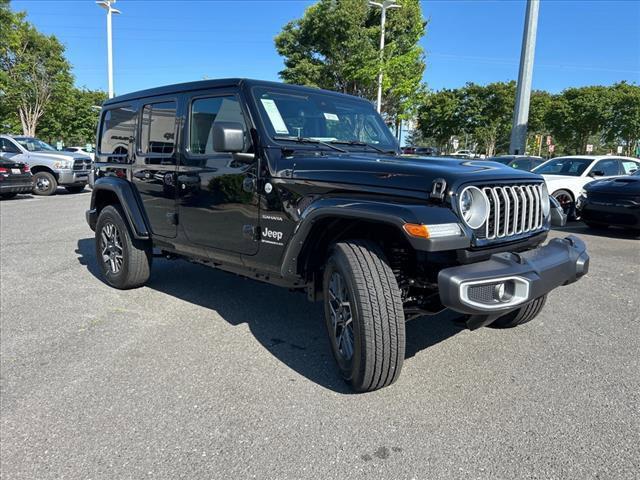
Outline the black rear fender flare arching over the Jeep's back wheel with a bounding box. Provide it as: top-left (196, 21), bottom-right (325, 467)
top-left (87, 177), bottom-right (151, 240)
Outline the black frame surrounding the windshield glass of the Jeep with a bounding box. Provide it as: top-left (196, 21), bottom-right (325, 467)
top-left (247, 84), bottom-right (400, 155)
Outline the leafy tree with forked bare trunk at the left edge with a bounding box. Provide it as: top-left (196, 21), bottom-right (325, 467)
top-left (0, 0), bottom-right (73, 135)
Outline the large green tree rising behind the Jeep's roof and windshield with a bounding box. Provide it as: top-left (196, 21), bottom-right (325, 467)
top-left (275, 0), bottom-right (426, 128)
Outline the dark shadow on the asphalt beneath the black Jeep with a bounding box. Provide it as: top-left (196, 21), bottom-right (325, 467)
top-left (76, 238), bottom-right (463, 394)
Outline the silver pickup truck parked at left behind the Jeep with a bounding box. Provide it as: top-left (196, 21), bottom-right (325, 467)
top-left (0, 135), bottom-right (91, 195)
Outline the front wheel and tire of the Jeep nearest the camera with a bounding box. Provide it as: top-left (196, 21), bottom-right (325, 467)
top-left (323, 240), bottom-right (405, 392)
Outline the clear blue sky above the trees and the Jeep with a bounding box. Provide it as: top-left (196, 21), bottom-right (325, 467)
top-left (11, 0), bottom-right (640, 94)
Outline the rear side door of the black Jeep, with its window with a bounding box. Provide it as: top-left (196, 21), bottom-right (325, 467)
top-left (133, 98), bottom-right (178, 238)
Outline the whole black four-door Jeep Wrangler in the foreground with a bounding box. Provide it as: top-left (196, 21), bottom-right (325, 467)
top-left (87, 79), bottom-right (589, 391)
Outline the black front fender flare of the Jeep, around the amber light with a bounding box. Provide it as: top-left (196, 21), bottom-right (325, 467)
top-left (280, 197), bottom-right (471, 279)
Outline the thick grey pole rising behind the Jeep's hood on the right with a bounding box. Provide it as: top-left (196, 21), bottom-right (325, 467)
top-left (509, 0), bottom-right (540, 155)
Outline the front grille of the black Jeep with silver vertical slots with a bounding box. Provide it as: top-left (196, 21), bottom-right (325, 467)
top-left (478, 184), bottom-right (544, 240)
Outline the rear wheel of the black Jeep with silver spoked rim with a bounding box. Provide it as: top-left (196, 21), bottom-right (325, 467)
top-left (95, 205), bottom-right (153, 290)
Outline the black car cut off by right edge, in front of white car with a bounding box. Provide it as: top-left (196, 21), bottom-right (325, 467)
top-left (577, 170), bottom-right (640, 231)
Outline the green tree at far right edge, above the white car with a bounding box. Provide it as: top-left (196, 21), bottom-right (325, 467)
top-left (605, 82), bottom-right (640, 155)
